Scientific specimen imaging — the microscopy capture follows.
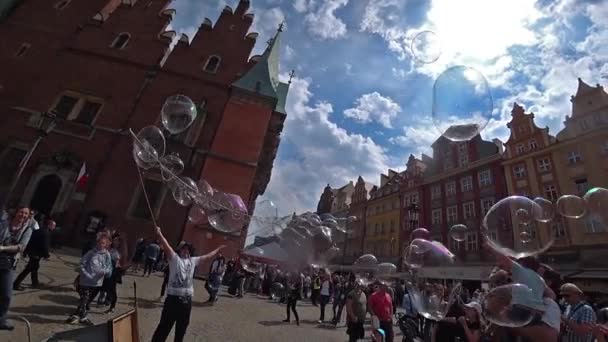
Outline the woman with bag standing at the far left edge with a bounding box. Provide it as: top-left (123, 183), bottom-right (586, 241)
top-left (0, 207), bottom-right (32, 330)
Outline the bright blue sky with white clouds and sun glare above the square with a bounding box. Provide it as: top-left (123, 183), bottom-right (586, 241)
top-left (166, 0), bottom-right (608, 239)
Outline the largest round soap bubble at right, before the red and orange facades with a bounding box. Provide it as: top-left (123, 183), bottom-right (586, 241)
top-left (481, 196), bottom-right (554, 258)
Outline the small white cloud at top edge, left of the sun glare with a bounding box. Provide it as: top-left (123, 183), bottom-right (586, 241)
top-left (302, 0), bottom-right (348, 39)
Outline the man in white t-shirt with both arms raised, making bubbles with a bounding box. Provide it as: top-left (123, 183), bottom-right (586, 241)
top-left (152, 227), bottom-right (226, 342)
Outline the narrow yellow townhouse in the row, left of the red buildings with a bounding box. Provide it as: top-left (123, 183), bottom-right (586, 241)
top-left (363, 170), bottom-right (400, 262)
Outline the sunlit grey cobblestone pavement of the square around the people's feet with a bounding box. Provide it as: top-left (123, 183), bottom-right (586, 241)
top-left (0, 249), bottom-right (358, 342)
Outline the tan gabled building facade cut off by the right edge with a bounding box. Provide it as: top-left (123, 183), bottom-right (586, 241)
top-left (552, 79), bottom-right (608, 254)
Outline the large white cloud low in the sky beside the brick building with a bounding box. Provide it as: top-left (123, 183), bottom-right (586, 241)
top-left (264, 78), bottom-right (389, 218)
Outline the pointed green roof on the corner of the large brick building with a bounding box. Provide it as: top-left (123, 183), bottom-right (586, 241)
top-left (232, 24), bottom-right (287, 99)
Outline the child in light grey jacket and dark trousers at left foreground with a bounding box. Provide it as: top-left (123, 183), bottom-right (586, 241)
top-left (66, 234), bottom-right (112, 325)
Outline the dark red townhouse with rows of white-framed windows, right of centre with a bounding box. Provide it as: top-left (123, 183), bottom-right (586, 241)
top-left (420, 135), bottom-right (513, 262)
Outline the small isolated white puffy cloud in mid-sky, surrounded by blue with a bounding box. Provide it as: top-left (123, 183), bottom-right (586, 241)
top-left (344, 92), bottom-right (401, 128)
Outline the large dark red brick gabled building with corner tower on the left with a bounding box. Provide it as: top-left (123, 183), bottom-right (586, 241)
top-left (0, 0), bottom-right (289, 268)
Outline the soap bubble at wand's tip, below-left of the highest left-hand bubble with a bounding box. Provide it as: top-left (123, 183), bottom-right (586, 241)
top-left (131, 126), bottom-right (165, 169)
